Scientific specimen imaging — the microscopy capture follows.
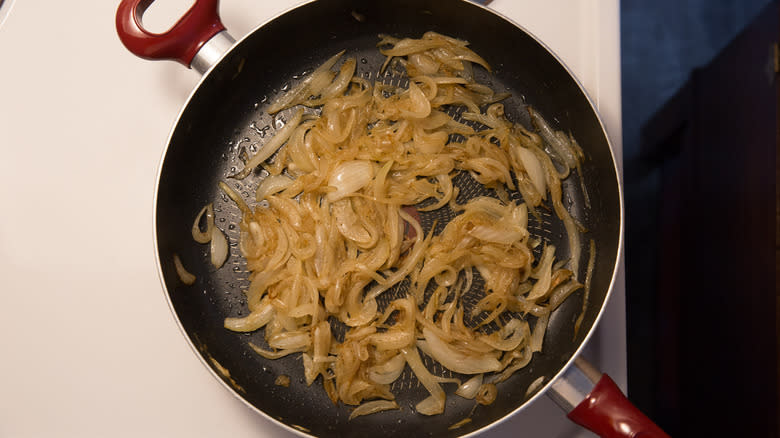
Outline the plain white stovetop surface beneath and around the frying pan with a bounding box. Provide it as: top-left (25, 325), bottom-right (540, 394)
top-left (0, 0), bottom-right (626, 438)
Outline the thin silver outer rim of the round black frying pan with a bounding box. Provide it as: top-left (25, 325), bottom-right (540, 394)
top-left (152, 0), bottom-right (625, 438)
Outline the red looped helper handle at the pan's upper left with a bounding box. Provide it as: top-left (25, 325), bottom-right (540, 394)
top-left (116, 0), bottom-right (225, 67)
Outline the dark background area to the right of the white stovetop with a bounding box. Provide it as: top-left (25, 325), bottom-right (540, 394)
top-left (621, 0), bottom-right (780, 437)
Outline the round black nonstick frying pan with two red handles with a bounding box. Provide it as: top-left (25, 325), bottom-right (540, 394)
top-left (116, 0), bottom-right (665, 436)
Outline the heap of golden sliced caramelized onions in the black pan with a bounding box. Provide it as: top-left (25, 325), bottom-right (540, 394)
top-left (207, 32), bottom-right (595, 419)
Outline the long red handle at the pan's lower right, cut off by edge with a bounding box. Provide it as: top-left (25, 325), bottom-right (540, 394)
top-left (567, 374), bottom-right (669, 438)
